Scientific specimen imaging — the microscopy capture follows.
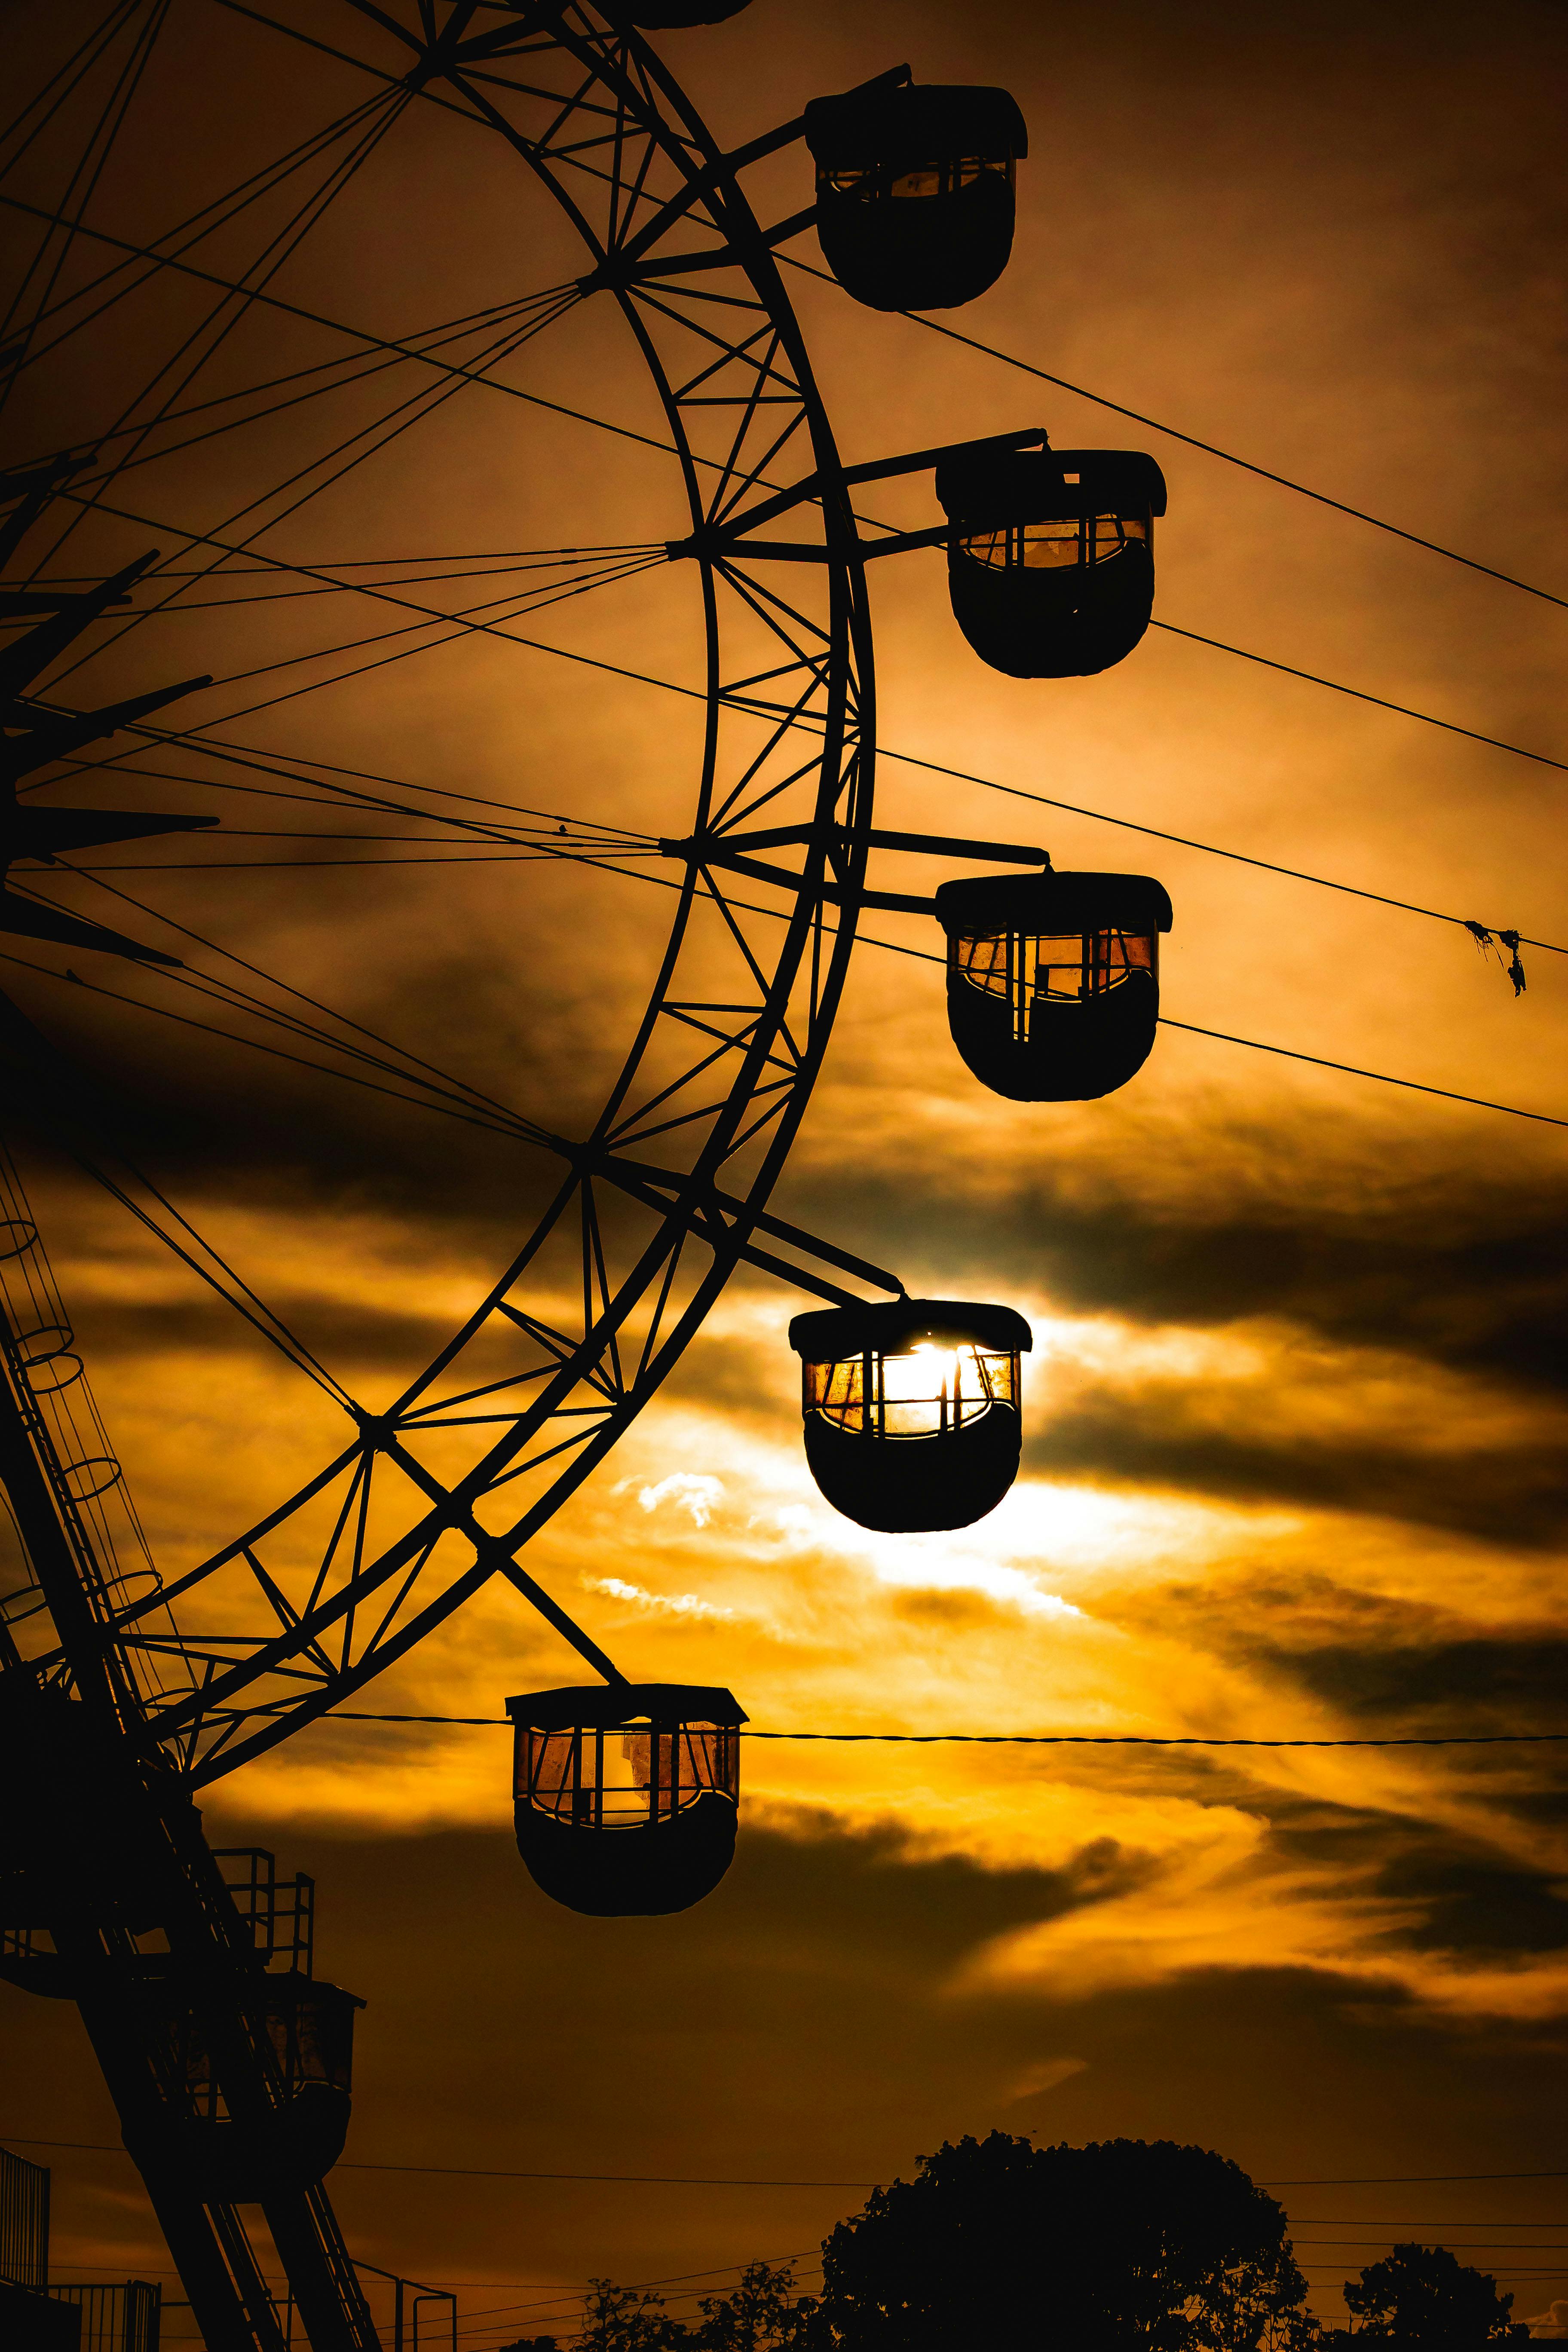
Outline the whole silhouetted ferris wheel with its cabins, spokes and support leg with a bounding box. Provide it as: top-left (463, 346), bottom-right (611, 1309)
top-left (0, 0), bottom-right (1171, 2352)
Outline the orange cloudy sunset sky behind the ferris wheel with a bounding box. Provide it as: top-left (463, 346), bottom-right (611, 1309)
top-left (0, 0), bottom-right (1568, 2352)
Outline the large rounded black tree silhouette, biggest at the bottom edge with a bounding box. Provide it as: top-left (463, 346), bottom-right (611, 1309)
top-left (816, 2131), bottom-right (1317, 2352)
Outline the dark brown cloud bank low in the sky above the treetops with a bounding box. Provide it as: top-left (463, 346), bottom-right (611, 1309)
top-left (12, 1802), bottom-right (1556, 2310)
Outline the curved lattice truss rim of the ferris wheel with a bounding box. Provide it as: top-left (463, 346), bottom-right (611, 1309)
top-left (0, 0), bottom-right (872, 1783)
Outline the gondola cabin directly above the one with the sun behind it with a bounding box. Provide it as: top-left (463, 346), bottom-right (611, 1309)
top-left (936, 873), bottom-right (1171, 1103)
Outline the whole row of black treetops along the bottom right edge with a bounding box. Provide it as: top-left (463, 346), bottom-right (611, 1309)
top-left (536, 2131), bottom-right (1528, 2352)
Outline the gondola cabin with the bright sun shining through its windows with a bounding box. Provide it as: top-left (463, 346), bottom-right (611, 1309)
top-left (790, 1298), bottom-right (1032, 1536)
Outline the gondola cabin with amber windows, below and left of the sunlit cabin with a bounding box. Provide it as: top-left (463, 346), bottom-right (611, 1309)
top-left (505, 1681), bottom-right (745, 1919)
